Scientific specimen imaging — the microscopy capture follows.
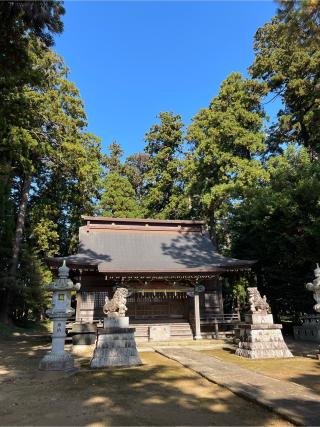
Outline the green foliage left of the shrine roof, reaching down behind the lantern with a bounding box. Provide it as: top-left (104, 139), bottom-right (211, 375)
top-left (0, 36), bottom-right (102, 319)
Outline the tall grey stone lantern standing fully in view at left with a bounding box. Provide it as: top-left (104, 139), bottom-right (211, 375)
top-left (39, 260), bottom-right (80, 371)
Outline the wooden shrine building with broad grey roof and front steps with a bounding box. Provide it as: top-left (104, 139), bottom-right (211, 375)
top-left (47, 216), bottom-right (255, 340)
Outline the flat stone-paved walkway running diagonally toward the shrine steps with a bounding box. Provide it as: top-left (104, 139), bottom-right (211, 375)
top-left (156, 348), bottom-right (320, 426)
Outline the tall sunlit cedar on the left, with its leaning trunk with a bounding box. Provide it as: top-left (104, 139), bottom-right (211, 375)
top-left (0, 37), bottom-right (100, 321)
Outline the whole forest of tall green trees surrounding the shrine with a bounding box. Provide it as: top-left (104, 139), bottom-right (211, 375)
top-left (0, 0), bottom-right (320, 323)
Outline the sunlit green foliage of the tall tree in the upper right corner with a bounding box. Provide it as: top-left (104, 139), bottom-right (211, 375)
top-left (251, 0), bottom-right (320, 158)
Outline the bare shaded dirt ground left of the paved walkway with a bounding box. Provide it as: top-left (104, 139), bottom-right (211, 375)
top-left (0, 339), bottom-right (290, 427)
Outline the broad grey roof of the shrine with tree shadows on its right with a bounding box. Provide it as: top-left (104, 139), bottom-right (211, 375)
top-left (49, 219), bottom-right (254, 274)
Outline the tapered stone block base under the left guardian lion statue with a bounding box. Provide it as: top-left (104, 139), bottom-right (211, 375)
top-left (90, 327), bottom-right (142, 368)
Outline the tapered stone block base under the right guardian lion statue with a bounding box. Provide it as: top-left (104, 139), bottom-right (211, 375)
top-left (236, 325), bottom-right (292, 359)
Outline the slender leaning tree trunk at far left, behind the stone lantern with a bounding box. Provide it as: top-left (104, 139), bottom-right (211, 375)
top-left (1, 175), bottom-right (32, 323)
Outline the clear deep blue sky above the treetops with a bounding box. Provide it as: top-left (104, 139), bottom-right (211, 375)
top-left (55, 1), bottom-right (276, 155)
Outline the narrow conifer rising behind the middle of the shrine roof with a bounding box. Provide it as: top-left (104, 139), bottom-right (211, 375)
top-left (143, 112), bottom-right (189, 219)
